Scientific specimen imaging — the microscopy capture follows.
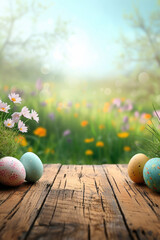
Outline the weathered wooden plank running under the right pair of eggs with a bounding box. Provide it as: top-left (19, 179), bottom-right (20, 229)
top-left (103, 165), bottom-right (160, 240)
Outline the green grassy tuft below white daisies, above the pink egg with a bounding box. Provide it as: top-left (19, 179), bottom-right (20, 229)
top-left (0, 123), bottom-right (19, 158)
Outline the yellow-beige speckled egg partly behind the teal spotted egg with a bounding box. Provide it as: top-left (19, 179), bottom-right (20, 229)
top-left (128, 153), bottom-right (149, 183)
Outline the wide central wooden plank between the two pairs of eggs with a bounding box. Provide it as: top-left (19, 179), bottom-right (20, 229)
top-left (27, 165), bottom-right (131, 240)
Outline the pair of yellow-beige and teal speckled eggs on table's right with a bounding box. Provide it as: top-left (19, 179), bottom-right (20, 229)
top-left (128, 153), bottom-right (160, 192)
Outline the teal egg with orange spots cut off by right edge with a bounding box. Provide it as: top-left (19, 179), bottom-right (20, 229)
top-left (143, 158), bottom-right (160, 192)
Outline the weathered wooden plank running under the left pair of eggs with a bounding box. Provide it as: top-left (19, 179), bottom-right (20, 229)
top-left (0, 164), bottom-right (61, 240)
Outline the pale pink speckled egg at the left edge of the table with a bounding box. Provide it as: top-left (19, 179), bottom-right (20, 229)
top-left (0, 156), bottom-right (26, 186)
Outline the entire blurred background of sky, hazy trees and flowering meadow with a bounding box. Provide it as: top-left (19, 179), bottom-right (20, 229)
top-left (0, 0), bottom-right (160, 164)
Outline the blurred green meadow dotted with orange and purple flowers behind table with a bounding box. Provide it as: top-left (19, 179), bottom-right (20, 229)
top-left (1, 79), bottom-right (154, 164)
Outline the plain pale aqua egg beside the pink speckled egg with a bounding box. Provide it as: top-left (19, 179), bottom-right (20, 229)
top-left (20, 152), bottom-right (43, 182)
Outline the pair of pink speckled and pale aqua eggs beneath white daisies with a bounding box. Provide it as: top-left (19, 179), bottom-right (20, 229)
top-left (0, 152), bottom-right (43, 186)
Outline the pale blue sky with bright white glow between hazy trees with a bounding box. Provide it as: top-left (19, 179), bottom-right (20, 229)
top-left (42, 0), bottom-right (158, 77)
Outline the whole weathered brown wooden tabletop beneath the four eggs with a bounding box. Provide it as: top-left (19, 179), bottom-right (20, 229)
top-left (0, 164), bottom-right (160, 240)
